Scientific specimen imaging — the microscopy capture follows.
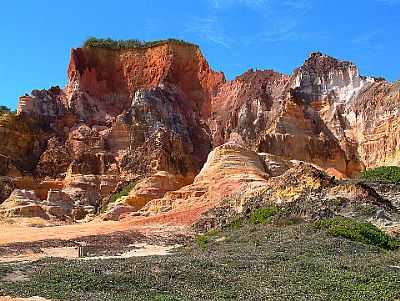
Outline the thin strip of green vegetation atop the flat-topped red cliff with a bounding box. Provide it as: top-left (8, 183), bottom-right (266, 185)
top-left (83, 37), bottom-right (197, 50)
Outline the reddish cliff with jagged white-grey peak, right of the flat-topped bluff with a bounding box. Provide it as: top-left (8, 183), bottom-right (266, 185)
top-left (210, 53), bottom-right (373, 175)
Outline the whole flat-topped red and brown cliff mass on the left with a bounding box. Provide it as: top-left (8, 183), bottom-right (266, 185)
top-left (0, 42), bottom-right (225, 219)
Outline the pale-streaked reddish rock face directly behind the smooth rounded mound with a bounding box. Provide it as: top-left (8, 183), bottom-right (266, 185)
top-left (208, 70), bottom-right (289, 147)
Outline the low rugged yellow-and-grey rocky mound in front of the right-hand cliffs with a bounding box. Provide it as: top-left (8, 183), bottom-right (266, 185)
top-left (195, 163), bottom-right (400, 231)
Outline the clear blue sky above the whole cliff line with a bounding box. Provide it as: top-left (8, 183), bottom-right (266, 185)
top-left (0, 0), bottom-right (400, 108)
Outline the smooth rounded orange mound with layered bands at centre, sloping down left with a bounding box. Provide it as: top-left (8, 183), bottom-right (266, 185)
top-left (141, 143), bottom-right (269, 215)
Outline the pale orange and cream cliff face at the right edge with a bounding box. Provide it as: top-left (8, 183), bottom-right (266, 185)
top-left (344, 81), bottom-right (400, 168)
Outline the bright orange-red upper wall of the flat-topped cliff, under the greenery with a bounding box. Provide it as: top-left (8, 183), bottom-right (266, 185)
top-left (66, 43), bottom-right (225, 118)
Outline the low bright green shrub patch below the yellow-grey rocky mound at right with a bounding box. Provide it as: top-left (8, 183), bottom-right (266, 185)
top-left (314, 217), bottom-right (400, 250)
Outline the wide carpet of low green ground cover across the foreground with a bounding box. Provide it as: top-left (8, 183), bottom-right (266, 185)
top-left (0, 222), bottom-right (400, 301)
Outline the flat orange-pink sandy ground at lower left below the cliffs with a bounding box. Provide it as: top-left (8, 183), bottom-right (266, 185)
top-left (0, 203), bottom-right (210, 263)
